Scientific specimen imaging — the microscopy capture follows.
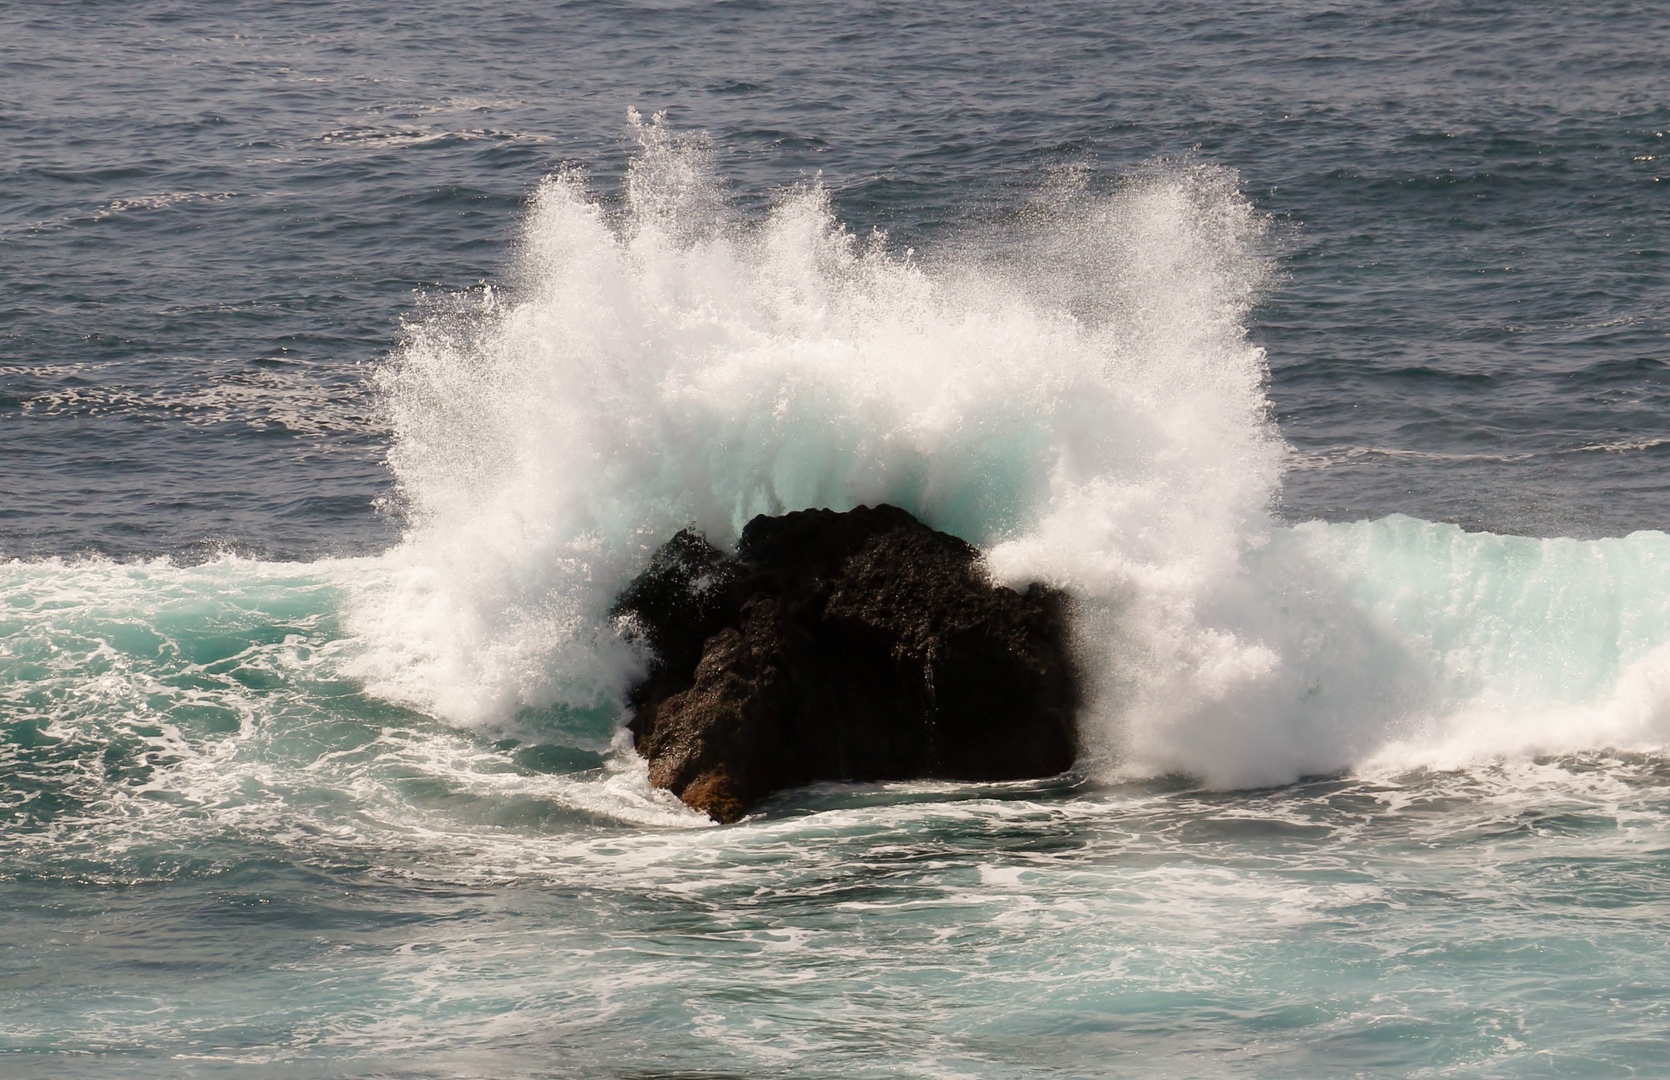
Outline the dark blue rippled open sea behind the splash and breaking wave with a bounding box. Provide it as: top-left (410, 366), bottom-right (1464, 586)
top-left (0, 3), bottom-right (1670, 558)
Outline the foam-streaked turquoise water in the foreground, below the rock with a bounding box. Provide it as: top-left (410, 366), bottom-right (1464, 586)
top-left (19, 760), bottom-right (1665, 1077)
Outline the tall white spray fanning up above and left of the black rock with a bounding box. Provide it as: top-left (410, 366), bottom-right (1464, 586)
top-left (357, 114), bottom-right (1281, 747)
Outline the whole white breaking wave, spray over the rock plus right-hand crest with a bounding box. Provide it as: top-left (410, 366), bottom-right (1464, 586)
top-left (349, 119), bottom-right (1670, 786)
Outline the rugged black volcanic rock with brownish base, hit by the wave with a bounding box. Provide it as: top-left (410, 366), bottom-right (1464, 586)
top-left (615, 506), bottom-right (1079, 821)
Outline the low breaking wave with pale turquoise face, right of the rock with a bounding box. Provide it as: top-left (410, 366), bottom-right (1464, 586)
top-left (1122, 516), bottom-right (1670, 786)
